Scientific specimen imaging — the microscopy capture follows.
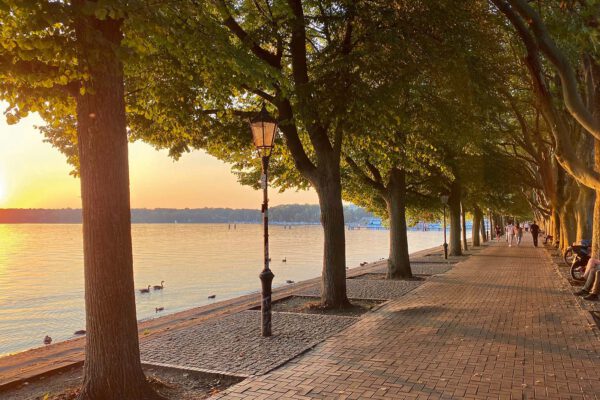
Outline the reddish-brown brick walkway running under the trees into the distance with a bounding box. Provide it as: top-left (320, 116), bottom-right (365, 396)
top-left (213, 241), bottom-right (600, 399)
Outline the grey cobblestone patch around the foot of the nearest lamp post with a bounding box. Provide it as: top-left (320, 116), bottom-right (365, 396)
top-left (140, 311), bottom-right (357, 375)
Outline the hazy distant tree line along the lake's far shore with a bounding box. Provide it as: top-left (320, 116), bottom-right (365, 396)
top-left (0, 204), bottom-right (373, 224)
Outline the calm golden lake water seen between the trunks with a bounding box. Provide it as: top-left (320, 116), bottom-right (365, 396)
top-left (0, 224), bottom-right (442, 355)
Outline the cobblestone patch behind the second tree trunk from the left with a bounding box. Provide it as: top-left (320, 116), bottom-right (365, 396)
top-left (297, 279), bottom-right (425, 300)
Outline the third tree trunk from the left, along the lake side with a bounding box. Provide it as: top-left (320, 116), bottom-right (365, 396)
top-left (385, 168), bottom-right (412, 279)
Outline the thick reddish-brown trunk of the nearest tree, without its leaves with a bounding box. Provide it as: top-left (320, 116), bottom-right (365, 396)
top-left (76, 17), bottom-right (158, 400)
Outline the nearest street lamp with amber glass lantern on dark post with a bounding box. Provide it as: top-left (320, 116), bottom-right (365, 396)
top-left (250, 104), bottom-right (277, 337)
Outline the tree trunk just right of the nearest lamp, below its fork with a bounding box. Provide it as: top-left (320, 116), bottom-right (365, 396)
top-left (316, 161), bottom-right (350, 308)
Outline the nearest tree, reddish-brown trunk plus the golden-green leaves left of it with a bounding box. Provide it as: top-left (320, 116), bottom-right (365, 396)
top-left (0, 0), bottom-right (164, 399)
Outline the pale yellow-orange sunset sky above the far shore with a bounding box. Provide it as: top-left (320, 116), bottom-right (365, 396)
top-left (0, 109), bottom-right (318, 208)
